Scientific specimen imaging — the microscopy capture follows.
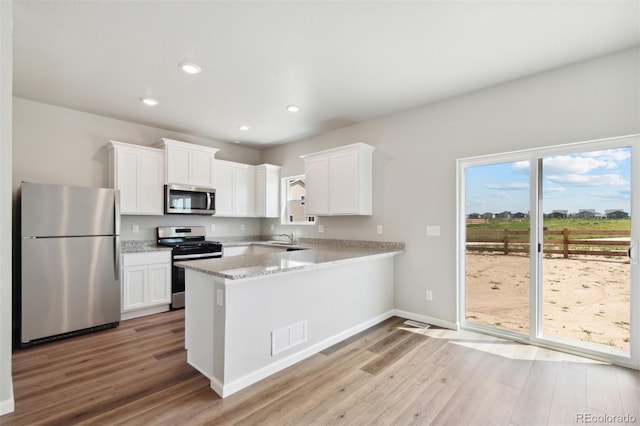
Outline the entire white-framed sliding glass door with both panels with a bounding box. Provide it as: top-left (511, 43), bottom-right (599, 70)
top-left (458, 136), bottom-right (640, 368)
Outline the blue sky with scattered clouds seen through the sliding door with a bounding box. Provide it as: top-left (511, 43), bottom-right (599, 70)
top-left (465, 148), bottom-right (631, 214)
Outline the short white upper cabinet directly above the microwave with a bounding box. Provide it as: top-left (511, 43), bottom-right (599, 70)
top-left (156, 138), bottom-right (219, 188)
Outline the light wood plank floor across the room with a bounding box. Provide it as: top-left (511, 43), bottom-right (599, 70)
top-left (0, 311), bottom-right (640, 425)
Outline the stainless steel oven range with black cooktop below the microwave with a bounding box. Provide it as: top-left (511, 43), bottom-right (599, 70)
top-left (157, 226), bottom-right (222, 310)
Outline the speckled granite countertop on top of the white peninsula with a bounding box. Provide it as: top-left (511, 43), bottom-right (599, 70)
top-left (175, 240), bottom-right (404, 280)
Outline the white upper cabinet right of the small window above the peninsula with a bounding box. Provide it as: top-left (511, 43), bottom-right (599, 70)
top-left (301, 143), bottom-right (375, 216)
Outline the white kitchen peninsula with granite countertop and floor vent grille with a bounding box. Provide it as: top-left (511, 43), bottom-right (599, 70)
top-left (176, 240), bottom-right (404, 397)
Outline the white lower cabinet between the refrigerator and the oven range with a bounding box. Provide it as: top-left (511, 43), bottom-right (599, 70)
top-left (121, 251), bottom-right (171, 320)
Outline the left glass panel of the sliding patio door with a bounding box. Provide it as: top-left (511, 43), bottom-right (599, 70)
top-left (464, 160), bottom-right (530, 334)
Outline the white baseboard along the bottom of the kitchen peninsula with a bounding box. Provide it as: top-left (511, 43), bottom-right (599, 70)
top-left (218, 310), bottom-right (395, 398)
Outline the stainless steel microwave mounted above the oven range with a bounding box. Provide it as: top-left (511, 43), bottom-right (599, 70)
top-left (164, 184), bottom-right (216, 215)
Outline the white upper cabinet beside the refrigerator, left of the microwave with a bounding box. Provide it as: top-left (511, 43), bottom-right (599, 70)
top-left (107, 141), bottom-right (165, 215)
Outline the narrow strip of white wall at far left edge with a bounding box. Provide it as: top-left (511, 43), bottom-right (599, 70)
top-left (0, 1), bottom-right (14, 415)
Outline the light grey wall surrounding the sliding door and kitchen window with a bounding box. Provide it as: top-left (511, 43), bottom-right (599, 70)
top-left (262, 49), bottom-right (640, 323)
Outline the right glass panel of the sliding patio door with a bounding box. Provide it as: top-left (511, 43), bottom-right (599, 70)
top-left (540, 146), bottom-right (632, 356)
